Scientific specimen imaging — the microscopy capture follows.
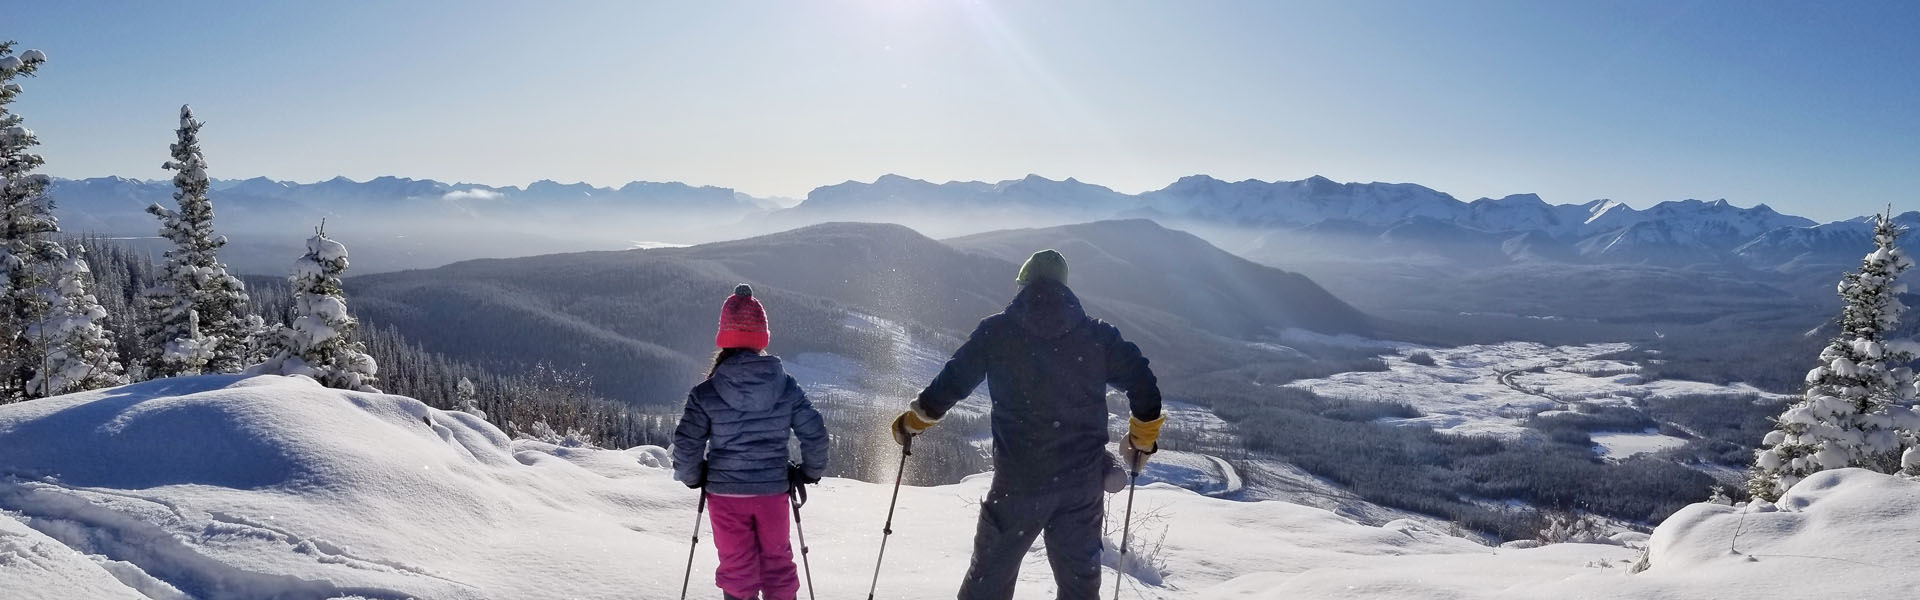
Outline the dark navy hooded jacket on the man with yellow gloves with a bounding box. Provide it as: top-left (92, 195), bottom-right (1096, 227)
top-left (916, 279), bottom-right (1160, 490)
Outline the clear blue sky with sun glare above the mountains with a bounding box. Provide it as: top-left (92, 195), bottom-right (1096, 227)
top-left (0, 0), bottom-right (1920, 219)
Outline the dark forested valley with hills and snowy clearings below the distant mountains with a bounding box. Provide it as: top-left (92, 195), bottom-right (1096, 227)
top-left (280, 210), bottom-right (1858, 540)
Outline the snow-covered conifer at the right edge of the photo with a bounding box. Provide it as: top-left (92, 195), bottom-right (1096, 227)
top-left (1747, 215), bottom-right (1920, 500)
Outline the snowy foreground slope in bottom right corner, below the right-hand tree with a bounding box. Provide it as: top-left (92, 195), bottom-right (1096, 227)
top-left (1204, 469), bottom-right (1920, 600)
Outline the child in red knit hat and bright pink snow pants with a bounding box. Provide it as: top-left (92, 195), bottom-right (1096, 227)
top-left (674, 285), bottom-right (828, 600)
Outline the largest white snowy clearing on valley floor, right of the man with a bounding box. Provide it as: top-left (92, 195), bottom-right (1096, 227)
top-left (1290, 342), bottom-right (1786, 437)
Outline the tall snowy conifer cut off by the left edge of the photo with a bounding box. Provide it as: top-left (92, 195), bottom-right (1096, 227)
top-left (0, 42), bottom-right (60, 402)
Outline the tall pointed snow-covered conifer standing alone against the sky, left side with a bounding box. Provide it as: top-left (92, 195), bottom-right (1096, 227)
top-left (144, 106), bottom-right (255, 377)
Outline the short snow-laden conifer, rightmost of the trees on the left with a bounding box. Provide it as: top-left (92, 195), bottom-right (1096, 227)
top-left (252, 225), bottom-right (378, 392)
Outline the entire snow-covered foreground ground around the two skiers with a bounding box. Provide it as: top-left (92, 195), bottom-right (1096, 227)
top-left (0, 377), bottom-right (1920, 598)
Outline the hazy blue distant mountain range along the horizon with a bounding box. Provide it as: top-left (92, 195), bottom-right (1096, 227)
top-left (50, 175), bottom-right (1920, 271)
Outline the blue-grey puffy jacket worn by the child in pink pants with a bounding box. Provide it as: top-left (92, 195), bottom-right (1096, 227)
top-left (674, 354), bottom-right (828, 496)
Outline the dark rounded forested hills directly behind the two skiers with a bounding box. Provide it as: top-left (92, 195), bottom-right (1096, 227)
top-left (348, 221), bottom-right (1371, 406)
